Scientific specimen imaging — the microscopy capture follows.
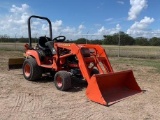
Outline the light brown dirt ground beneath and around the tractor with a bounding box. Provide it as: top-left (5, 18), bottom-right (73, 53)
top-left (0, 52), bottom-right (160, 120)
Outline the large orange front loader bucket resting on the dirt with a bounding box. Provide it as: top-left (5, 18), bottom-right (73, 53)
top-left (86, 70), bottom-right (142, 106)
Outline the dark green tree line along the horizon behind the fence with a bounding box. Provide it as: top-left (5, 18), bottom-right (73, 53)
top-left (0, 31), bottom-right (160, 46)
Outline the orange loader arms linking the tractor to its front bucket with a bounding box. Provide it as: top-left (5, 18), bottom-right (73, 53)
top-left (54, 43), bottom-right (113, 81)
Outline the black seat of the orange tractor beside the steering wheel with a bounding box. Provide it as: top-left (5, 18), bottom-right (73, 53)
top-left (38, 36), bottom-right (51, 50)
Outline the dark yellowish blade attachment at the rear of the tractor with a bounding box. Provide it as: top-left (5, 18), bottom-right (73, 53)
top-left (8, 58), bottom-right (24, 70)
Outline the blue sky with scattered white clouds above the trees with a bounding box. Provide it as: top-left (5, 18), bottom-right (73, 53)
top-left (0, 0), bottom-right (160, 39)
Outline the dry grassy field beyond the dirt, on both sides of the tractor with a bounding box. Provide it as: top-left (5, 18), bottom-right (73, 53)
top-left (0, 43), bottom-right (160, 73)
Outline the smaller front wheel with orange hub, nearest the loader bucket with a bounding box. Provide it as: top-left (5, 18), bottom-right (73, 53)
top-left (54, 71), bottom-right (71, 91)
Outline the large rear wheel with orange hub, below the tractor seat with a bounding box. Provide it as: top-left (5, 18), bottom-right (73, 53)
top-left (22, 57), bottom-right (42, 81)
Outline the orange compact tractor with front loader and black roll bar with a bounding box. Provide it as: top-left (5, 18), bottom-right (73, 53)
top-left (9, 15), bottom-right (141, 105)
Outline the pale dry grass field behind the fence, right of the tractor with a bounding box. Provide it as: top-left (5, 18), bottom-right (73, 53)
top-left (103, 45), bottom-right (160, 59)
